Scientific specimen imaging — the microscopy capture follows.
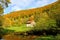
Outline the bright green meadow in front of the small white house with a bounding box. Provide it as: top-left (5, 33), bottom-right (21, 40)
top-left (4, 25), bottom-right (32, 32)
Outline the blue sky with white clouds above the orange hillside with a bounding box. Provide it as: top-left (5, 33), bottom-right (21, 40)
top-left (4, 0), bottom-right (57, 14)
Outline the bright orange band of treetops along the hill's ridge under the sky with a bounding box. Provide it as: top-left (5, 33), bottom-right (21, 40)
top-left (4, 0), bottom-right (59, 17)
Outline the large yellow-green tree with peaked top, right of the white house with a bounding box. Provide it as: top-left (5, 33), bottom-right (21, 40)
top-left (35, 12), bottom-right (56, 30)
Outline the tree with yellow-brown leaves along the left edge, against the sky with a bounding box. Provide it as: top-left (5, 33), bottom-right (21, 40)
top-left (0, 0), bottom-right (10, 26)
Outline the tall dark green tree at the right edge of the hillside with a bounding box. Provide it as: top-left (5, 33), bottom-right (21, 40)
top-left (49, 2), bottom-right (60, 27)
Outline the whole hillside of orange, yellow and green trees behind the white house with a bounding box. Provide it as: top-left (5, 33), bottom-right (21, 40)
top-left (3, 0), bottom-right (60, 27)
